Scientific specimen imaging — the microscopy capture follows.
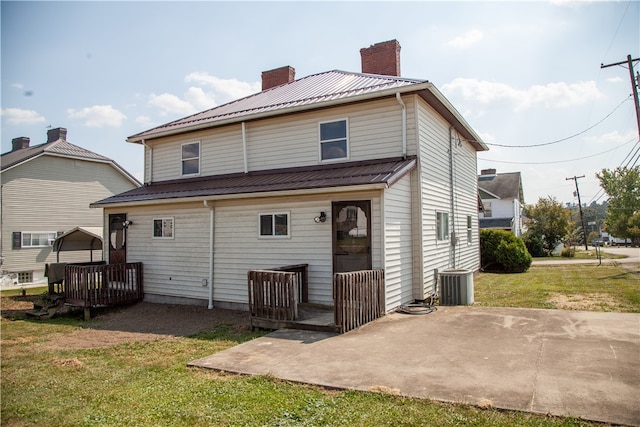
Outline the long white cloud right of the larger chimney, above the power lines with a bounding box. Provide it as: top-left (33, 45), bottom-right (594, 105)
top-left (442, 78), bottom-right (603, 111)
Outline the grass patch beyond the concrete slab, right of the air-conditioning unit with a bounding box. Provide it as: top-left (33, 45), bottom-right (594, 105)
top-left (474, 264), bottom-right (640, 313)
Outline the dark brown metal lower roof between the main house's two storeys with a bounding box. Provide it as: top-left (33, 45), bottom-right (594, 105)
top-left (91, 157), bottom-right (416, 207)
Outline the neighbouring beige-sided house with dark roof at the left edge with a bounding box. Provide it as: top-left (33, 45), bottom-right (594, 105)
top-left (0, 128), bottom-right (140, 283)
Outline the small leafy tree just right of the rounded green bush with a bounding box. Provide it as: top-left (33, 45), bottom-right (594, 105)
top-left (524, 196), bottom-right (571, 255)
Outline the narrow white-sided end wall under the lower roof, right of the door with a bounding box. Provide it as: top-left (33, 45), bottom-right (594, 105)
top-left (384, 175), bottom-right (413, 312)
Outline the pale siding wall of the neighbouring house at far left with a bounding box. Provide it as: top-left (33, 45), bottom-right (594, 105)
top-left (1, 155), bottom-right (134, 279)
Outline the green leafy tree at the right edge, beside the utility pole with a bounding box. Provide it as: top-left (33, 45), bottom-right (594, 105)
top-left (596, 166), bottom-right (640, 243)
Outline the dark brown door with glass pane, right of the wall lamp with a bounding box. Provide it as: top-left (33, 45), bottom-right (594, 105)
top-left (331, 200), bottom-right (371, 273)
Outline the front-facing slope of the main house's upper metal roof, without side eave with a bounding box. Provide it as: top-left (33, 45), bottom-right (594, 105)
top-left (127, 70), bottom-right (428, 142)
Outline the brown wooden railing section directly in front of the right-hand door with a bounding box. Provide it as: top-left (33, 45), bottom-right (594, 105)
top-left (333, 270), bottom-right (385, 333)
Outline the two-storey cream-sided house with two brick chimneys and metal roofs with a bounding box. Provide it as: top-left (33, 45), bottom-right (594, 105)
top-left (93, 40), bottom-right (487, 310)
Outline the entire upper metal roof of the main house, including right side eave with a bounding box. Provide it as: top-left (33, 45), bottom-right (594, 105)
top-left (127, 70), bottom-right (488, 151)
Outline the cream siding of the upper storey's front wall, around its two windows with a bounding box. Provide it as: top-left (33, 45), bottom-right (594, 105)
top-left (146, 97), bottom-right (416, 182)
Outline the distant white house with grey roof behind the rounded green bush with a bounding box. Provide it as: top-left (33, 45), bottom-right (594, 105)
top-left (478, 169), bottom-right (524, 237)
